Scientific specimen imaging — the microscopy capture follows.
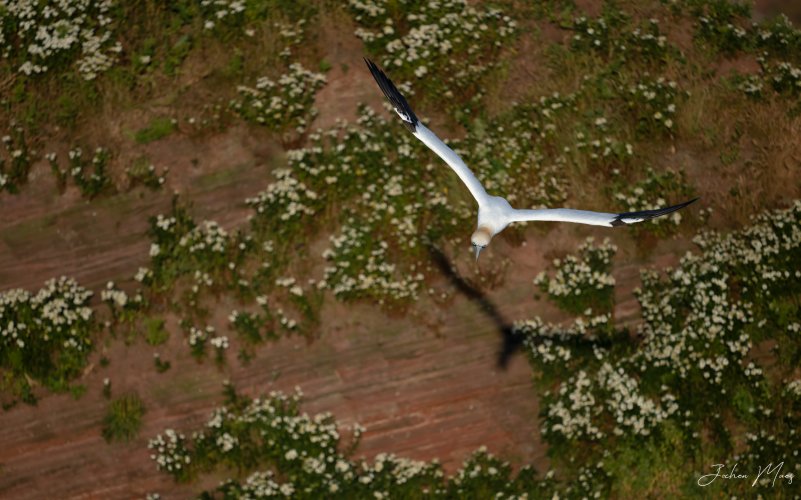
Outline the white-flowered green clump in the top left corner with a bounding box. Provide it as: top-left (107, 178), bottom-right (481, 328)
top-left (0, 0), bottom-right (122, 80)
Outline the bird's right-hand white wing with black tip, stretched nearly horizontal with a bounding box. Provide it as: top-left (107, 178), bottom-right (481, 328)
top-left (509, 198), bottom-right (698, 227)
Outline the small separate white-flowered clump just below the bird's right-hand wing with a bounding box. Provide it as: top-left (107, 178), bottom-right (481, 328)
top-left (534, 237), bottom-right (617, 312)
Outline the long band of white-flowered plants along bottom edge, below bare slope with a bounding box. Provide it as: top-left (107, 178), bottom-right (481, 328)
top-left (150, 388), bottom-right (526, 499)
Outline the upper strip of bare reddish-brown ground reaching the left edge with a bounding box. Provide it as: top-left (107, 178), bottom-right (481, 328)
top-left (0, 123), bottom-right (281, 289)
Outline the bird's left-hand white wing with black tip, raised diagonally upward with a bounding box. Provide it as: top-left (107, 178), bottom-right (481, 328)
top-left (364, 59), bottom-right (488, 205)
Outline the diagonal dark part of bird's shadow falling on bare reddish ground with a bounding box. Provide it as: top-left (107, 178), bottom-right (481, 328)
top-left (426, 243), bottom-right (523, 369)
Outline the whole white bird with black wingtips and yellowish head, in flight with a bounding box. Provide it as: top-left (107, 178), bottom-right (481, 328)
top-left (364, 58), bottom-right (698, 260)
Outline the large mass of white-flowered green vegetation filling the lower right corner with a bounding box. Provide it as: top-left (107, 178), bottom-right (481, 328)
top-left (517, 202), bottom-right (801, 496)
